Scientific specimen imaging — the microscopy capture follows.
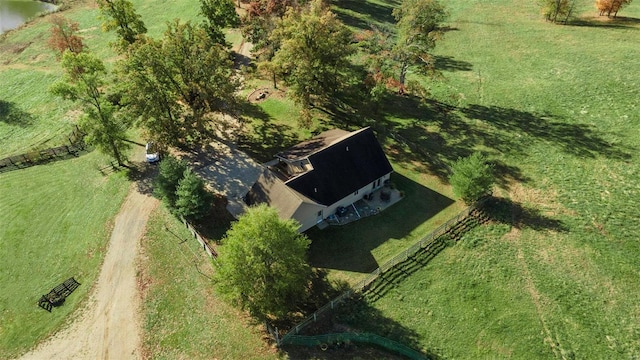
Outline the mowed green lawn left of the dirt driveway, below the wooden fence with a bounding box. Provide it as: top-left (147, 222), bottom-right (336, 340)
top-left (0, 152), bottom-right (129, 358)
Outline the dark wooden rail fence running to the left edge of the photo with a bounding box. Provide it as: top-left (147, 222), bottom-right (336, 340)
top-left (0, 126), bottom-right (87, 172)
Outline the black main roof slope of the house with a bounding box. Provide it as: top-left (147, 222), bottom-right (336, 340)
top-left (286, 127), bottom-right (393, 206)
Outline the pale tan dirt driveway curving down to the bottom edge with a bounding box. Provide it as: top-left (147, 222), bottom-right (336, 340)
top-left (21, 184), bottom-right (158, 360)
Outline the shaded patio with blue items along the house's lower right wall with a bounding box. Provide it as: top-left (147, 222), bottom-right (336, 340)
top-left (318, 186), bottom-right (402, 229)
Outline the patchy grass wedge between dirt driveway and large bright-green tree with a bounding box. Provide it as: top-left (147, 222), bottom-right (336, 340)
top-left (139, 206), bottom-right (279, 359)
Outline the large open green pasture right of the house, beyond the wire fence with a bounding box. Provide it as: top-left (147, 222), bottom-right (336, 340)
top-left (324, 1), bottom-right (640, 359)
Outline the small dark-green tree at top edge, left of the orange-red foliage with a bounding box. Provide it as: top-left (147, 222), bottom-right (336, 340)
top-left (200, 0), bottom-right (240, 47)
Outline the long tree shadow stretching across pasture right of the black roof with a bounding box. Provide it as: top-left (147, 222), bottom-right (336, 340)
top-left (336, 94), bottom-right (633, 189)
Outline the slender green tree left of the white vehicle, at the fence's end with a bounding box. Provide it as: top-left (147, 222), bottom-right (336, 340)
top-left (50, 51), bottom-right (129, 166)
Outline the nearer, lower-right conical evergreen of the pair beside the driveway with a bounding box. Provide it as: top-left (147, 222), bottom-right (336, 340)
top-left (174, 168), bottom-right (213, 220)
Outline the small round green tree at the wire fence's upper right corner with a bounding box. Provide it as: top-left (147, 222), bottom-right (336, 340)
top-left (449, 152), bottom-right (495, 204)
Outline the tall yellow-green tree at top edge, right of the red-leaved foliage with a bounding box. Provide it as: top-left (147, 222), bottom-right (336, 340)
top-left (391, 0), bottom-right (448, 92)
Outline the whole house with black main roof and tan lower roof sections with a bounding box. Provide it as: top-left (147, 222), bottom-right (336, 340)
top-left (245, 127), bottom-right (393, 232)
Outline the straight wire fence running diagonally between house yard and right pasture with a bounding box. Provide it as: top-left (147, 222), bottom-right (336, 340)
top-left (278, 197), bottom-right (489, 346)
